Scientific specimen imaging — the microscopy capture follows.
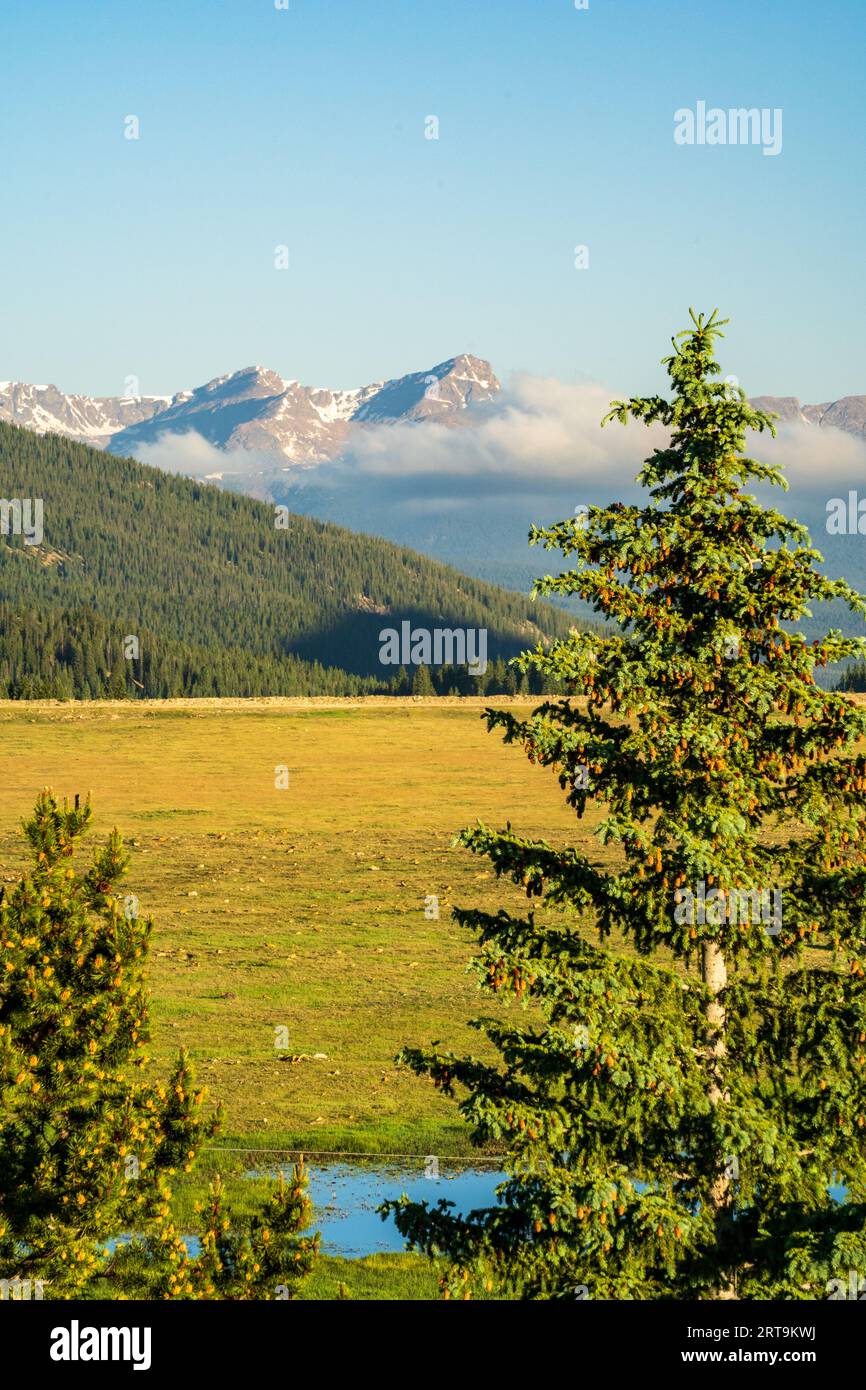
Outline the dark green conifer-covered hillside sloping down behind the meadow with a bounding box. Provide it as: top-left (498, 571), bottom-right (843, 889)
top-left (0, 423), bottom-right (583, 696)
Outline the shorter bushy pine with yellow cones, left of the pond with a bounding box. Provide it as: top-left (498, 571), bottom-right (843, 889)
top-left (0, 791), bottom-right (317, 1298)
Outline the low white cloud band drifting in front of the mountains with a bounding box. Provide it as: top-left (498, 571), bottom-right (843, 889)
top-left (127, 375), bottom-right (866, 502)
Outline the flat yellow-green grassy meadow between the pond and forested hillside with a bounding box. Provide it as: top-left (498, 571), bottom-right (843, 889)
top-left (0, 699), bottom-right (601, 1154)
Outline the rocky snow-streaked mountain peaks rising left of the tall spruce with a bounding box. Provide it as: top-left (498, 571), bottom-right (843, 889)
top-left (0, 353), bottom-right (500, 467)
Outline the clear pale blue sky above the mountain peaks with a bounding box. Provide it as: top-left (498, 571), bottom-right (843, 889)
top-left (0, 0), bottom-right (866, 402)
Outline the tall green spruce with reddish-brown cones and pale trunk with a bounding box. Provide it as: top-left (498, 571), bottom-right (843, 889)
top-left (396, 313), bottom-right (866, 1298)
